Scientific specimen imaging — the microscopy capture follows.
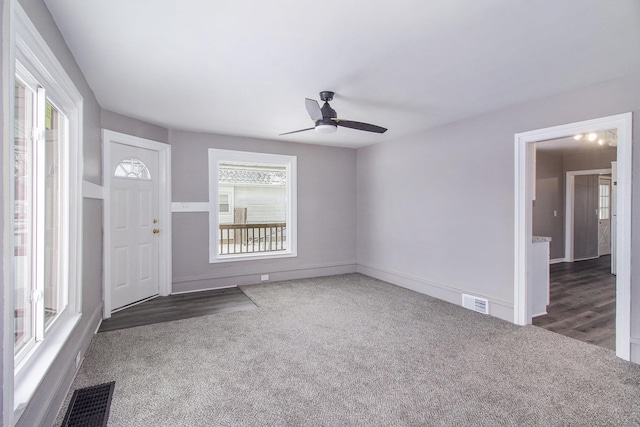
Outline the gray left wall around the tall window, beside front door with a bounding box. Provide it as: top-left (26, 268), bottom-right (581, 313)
top-left (3, 0), bottom-right (102, 426)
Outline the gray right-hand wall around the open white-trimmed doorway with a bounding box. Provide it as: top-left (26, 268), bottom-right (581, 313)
top-left (357, 75), bottom-right (640, 362)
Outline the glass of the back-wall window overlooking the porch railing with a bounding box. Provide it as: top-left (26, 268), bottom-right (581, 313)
top-left (217, 162), bottom-right (288, 255)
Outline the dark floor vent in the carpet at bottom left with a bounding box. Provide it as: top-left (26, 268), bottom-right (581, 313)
top-left (62, 381), bottom-right (115, 427)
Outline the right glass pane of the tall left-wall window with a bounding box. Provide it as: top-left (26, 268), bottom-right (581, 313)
top-left (43, 102), bottom-right (66, 327)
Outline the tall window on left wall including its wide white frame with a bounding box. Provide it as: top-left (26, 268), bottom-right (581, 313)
top-left (8, 4), bottom-right (82, 420)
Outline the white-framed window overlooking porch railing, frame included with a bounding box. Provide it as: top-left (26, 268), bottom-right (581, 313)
top-left (209, 149), bottom-right (297, 262)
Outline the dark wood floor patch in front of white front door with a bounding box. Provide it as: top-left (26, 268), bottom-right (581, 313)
top-left (98, 288), bottom-right (256, 332)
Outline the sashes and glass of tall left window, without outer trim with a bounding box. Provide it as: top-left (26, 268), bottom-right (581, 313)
top-left (13, 64), bottom-right (69, 361)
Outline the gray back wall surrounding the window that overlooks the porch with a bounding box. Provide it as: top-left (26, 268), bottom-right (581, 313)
top-left (169, 131), bottom-right (356, 292)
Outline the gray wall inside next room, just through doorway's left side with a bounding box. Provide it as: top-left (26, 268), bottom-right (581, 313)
top-left (532, 151), bottom-right (565, 259)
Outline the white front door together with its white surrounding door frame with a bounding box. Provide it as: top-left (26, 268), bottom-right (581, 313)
top-left (103, 130), bottom-right (171, 319)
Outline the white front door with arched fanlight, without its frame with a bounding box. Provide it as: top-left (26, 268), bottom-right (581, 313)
top-left (107, 142), bottom-right (160, 311)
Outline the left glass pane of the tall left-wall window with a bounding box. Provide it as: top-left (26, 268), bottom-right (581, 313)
top-left (13, 79), bottom-right (35, 354)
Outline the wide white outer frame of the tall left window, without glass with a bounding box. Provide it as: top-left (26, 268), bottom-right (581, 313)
top-left (3, 2), bottom-right (83, 425)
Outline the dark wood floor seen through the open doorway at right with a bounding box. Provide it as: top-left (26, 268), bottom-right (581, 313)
top-left (533, 255), bottom-right (616, 350)
